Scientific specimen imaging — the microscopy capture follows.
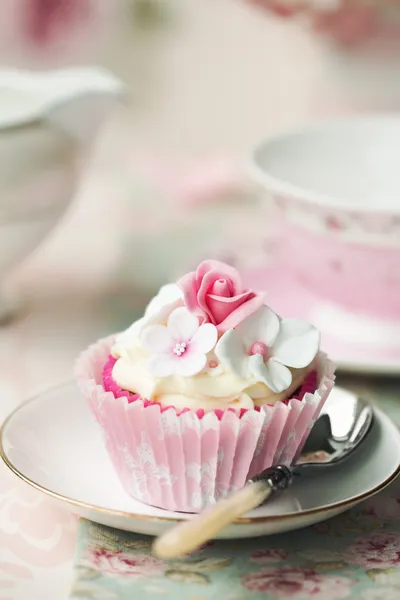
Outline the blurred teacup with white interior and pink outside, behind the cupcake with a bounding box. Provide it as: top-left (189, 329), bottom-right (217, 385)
top-left (252, 115), bottom-right (400, 321)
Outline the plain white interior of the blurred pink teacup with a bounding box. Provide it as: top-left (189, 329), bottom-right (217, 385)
top-left (254, 114), bottom-right (400, 215)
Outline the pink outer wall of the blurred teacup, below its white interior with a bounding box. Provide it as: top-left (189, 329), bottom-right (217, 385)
top-left (272, 220), bottom-right (400, 319)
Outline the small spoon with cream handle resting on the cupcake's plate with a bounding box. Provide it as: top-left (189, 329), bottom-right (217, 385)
top-left (153, 388), bottom-right (374, 559)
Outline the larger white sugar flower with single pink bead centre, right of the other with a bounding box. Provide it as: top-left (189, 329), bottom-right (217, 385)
top-left (215, 306), bottom-right (320, 393)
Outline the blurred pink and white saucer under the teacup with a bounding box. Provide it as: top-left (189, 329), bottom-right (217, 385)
top-left (242, 267), bottom-right (400, 375)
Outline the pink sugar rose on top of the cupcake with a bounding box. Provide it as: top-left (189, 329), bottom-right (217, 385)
top-left (178, 260), bottom-right (264, 333)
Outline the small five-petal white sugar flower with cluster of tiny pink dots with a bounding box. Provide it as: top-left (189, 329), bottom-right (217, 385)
top-left (140, 307), bottom-right (218, 377)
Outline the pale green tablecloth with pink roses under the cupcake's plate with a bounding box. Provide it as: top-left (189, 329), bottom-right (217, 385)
top-left (62, 378), bottom-right (400, 600)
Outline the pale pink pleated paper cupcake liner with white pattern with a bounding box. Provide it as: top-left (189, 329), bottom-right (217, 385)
top-left (75, 338), bottom-right (334, 512)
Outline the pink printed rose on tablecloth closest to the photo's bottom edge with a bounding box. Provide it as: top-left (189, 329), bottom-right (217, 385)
top-left (242, 567), bottom-right (353, 600)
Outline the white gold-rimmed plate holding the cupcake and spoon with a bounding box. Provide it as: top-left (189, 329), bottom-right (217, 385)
top-left (0, 383), bottom-right (400, 538)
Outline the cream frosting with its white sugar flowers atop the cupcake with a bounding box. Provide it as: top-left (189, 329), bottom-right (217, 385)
top-left (111, 272), bottom-right (319, 411)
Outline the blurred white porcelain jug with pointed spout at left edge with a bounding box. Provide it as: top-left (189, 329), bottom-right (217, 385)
top-left (0, 68), bottom-right (123, 317)
